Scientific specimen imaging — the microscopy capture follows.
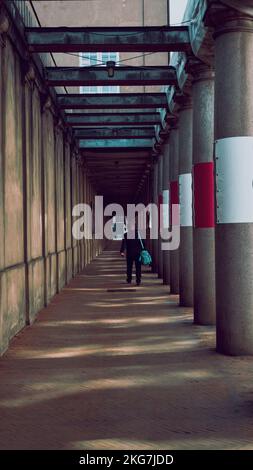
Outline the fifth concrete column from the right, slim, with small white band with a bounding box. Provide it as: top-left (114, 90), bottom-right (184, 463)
top-left (162, 141), bottom-right (170, 285)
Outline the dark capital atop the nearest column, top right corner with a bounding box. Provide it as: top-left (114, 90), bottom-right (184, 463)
top-left (205, 0), bottom-right (253, 39)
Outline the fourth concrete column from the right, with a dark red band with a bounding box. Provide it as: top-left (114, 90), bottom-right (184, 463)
top-left (169, 125), bottom-right (179, 294)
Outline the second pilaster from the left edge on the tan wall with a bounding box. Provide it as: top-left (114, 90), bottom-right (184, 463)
top-left (22, 73), bottom-right (45, 323)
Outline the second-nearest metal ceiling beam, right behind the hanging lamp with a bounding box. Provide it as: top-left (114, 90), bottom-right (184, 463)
top-left (45, 66), bottom-right (177, 86)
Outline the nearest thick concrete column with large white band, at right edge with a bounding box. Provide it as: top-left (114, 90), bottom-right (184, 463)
top-left (214, 10), bottom-right (253, 355)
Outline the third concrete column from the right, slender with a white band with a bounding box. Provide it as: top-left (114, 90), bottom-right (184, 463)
top-left (179, 97), bottom-right (193, 307)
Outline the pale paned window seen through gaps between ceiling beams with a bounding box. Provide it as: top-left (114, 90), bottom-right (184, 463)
top-left (79, 52), bottom-right (120, 93)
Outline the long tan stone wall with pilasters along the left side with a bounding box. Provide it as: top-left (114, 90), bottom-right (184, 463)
top-left (0, 22), bottom-right (102, 354)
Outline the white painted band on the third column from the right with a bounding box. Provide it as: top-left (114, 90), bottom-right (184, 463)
top-left (179, 173), bottom-right (192, 227)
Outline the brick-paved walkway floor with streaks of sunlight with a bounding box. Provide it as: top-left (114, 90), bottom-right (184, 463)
top-left (0, 244), bottom-right (253, 449)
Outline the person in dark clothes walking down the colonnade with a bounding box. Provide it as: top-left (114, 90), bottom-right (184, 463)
top-left (120, 214), bottom-right (145, 286)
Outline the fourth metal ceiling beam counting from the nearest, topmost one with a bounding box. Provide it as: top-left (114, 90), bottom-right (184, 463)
top-left (65, 113), bottom-right (161, 126)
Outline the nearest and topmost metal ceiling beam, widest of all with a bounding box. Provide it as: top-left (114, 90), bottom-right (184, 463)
top-left (26, 26), bottom-right (190, 52)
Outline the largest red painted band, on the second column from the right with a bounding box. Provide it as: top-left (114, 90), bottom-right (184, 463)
top-left (193, 162), bottom-right (215, 228)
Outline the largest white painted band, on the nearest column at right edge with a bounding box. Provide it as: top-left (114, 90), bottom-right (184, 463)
top-left (215, 137), bottom-right (253, 224)
